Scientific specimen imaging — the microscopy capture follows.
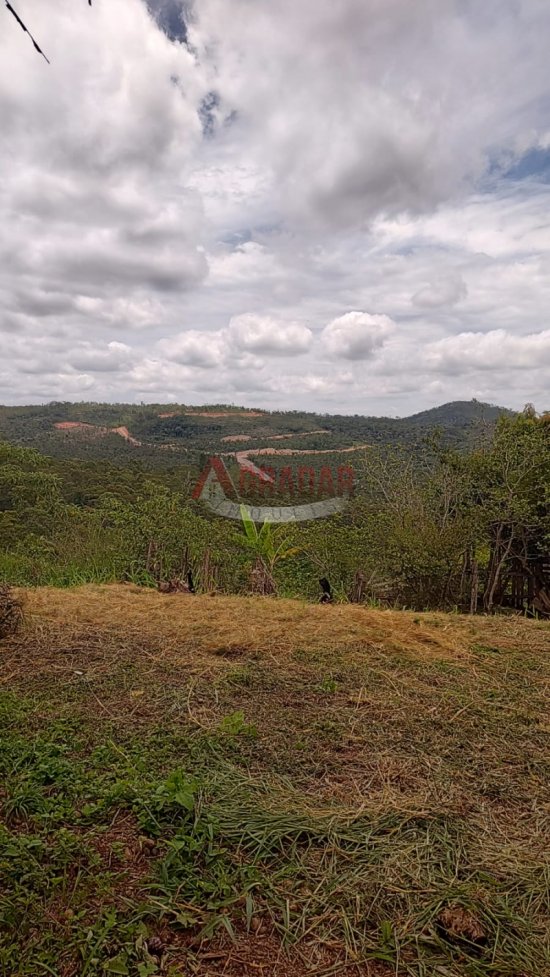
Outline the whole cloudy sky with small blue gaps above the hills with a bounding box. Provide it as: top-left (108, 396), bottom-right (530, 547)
top-left (0, 0), bottom-right (550, 416)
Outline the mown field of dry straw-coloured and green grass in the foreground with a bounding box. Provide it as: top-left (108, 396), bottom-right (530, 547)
top-left (0, 585), bottom-right (550, 977)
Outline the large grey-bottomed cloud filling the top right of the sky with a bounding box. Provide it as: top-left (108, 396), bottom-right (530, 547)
top-left (189, 0), bottom-right (548, 226)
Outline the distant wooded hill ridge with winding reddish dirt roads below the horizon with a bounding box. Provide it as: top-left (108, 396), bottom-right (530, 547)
top-left (0, 400), bottom-right (512, 469)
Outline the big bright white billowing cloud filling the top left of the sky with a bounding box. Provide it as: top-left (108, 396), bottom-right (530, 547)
top-left (0, 0), bottom-right (207, 340)
